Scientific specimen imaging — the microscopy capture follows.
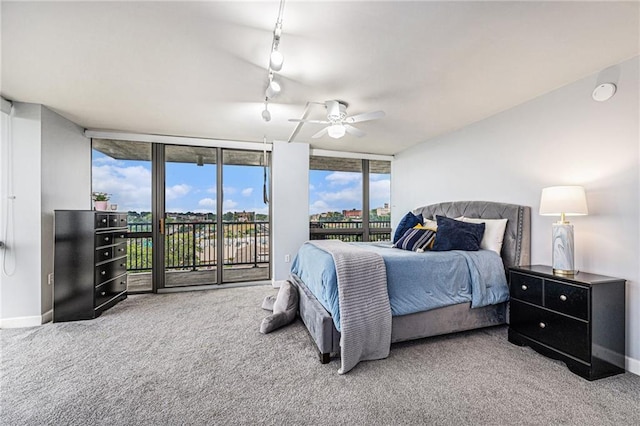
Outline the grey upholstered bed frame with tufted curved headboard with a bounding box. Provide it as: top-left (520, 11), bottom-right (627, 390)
top-left (291, 201), bottom-right (531, 370)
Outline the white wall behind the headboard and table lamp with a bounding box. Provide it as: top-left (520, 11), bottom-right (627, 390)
top-left (392, 57), bottom-right (640, 374)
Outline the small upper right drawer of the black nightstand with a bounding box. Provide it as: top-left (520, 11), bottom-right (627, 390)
top-left (544, 280), bottom-right (589, 320)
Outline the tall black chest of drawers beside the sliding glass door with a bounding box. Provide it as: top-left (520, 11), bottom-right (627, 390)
top-left (53, 210), bottom-right (127, 322)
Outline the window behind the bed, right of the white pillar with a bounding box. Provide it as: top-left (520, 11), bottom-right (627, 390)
top-left (309, 156), bottom-right (391, 241)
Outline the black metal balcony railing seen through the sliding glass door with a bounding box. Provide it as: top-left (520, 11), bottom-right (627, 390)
top-left (127, 222), bottom-right (270, 272)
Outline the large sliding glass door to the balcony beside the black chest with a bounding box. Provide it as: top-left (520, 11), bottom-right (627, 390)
top-left (93, 139), bottom-right (271, 292)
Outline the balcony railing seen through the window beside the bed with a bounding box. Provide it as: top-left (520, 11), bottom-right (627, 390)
top-left (309, 220), bottom-right (391, 242)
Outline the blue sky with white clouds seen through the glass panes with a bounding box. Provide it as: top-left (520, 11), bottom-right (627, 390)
top-left (92, 151), bottom-right (390, 214)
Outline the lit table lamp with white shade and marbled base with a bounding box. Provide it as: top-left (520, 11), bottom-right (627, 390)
top-left (540, 186), bottom-right (588, 275)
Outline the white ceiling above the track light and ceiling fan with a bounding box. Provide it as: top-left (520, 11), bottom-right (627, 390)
top-left (1, 0), bottom-right (640, 154)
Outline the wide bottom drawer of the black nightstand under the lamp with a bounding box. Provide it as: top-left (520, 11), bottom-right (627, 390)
top-left (510, 300), bottom-right (591, 362)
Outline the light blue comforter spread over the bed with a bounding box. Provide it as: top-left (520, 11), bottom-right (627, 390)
top-left (291, 243), bottom-right (509, 331)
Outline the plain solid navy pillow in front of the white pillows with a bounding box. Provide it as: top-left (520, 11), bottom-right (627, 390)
top-left (431, 216), bottom-right (484, 251)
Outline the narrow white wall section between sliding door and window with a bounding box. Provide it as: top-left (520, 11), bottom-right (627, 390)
top-left (271, 141), bottom-right (309, 283)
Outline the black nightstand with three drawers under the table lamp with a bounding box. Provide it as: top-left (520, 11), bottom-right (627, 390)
top-left (509, 265), bottom-right (625, 380)
